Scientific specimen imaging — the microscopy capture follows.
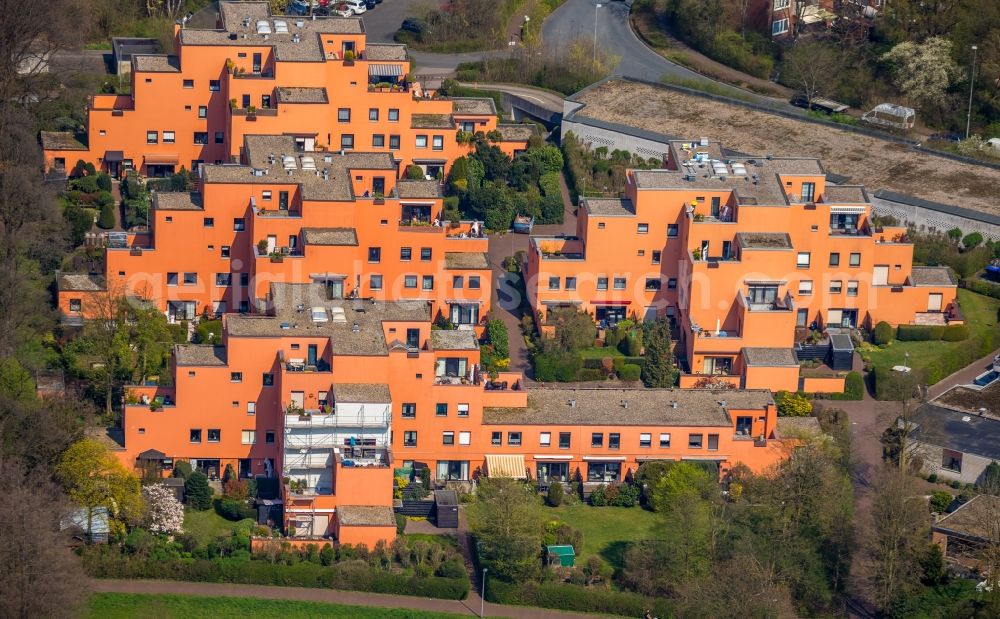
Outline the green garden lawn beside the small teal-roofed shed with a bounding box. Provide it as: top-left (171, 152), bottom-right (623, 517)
top-left (544, 504), bottom-right (660, 569)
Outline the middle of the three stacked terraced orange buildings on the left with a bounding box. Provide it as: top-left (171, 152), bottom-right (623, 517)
top-left (59, 135), bottom-right (491, 328)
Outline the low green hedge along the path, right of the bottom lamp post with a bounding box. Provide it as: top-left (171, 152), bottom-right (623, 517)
top-left (486, 580), bottom-right (673, 617)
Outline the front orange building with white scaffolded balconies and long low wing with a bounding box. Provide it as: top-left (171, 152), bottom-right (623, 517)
top-left (119, 283), bottom-right (794, 545)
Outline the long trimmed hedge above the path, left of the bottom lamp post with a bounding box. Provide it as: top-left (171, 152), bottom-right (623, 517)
top-left (83, 551), bottom-right (469, 600)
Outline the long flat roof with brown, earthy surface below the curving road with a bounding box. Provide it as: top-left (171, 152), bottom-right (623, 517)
top-left (578, 80), bottom-right (1000, 215)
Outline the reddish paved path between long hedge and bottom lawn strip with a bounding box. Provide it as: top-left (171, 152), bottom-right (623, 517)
top-left (90, 580), bottom-right (601, 619)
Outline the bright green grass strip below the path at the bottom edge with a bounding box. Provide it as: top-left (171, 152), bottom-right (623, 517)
top-left (83, 593), bottom-right (461, 619)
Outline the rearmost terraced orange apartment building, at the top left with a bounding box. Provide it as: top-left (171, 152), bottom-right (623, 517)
top-left (42, 2), bottom-right (530, 179)
